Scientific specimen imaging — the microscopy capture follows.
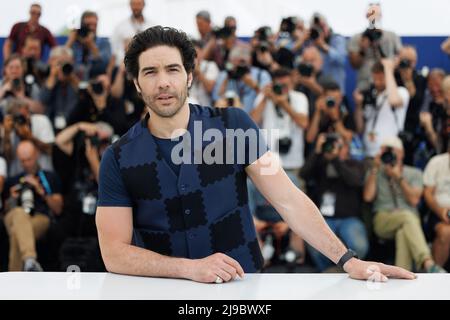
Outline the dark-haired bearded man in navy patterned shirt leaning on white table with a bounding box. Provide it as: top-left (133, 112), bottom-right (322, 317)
top-left (96, 26), bottom-right (415, 283)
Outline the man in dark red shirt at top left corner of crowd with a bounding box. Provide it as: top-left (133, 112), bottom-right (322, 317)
top-left (3, 3), bottom-right (56, 59)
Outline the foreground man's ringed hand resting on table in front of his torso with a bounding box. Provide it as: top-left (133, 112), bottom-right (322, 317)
top-left (187, 253), bottom-right (244, 283)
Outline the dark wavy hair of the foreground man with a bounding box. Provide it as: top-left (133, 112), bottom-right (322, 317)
top-left (124, 26), bottom-right (197, 79)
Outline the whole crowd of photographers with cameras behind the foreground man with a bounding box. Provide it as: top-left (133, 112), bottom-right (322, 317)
top-left (0, 0), bottom-right (450, 272)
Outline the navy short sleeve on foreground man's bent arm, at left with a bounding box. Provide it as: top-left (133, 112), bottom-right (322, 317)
top-left (97, 146), bottom-right (132, 207)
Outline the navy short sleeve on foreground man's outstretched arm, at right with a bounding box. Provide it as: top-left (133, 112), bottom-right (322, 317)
top-left (226, 107), bottom-right (269, 166)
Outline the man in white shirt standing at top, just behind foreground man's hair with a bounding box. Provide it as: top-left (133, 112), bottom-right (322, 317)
top-left (111, 0), bottom-right (153, 65)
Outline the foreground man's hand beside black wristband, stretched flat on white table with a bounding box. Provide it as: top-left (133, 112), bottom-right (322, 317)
top-left (344, 258), bottom-right (417, 282)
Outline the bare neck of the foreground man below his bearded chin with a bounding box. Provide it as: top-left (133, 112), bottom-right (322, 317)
top-left (147, 102), bottom-right (190, 139)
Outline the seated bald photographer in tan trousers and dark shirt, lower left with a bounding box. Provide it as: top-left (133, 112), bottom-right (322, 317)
top-left (5, 141), bottom-right (63, 271)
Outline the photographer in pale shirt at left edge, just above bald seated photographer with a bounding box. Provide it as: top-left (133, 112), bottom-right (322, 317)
top-left (1, 99), bottom-right (55, 176)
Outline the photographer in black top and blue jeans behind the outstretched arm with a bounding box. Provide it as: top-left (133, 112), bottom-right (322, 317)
top-left (300, 133), bottom-right (369, 272)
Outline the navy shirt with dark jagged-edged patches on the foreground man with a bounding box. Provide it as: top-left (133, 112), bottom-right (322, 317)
top-left (98, 104), bottom-right (267, 272)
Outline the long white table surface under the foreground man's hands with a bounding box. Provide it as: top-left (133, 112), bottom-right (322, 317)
top-left (0, 272), bottom-right (450, 300)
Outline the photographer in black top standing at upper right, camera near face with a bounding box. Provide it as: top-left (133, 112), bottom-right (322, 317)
top-left (395, 46), bottom-right (427, 165)
